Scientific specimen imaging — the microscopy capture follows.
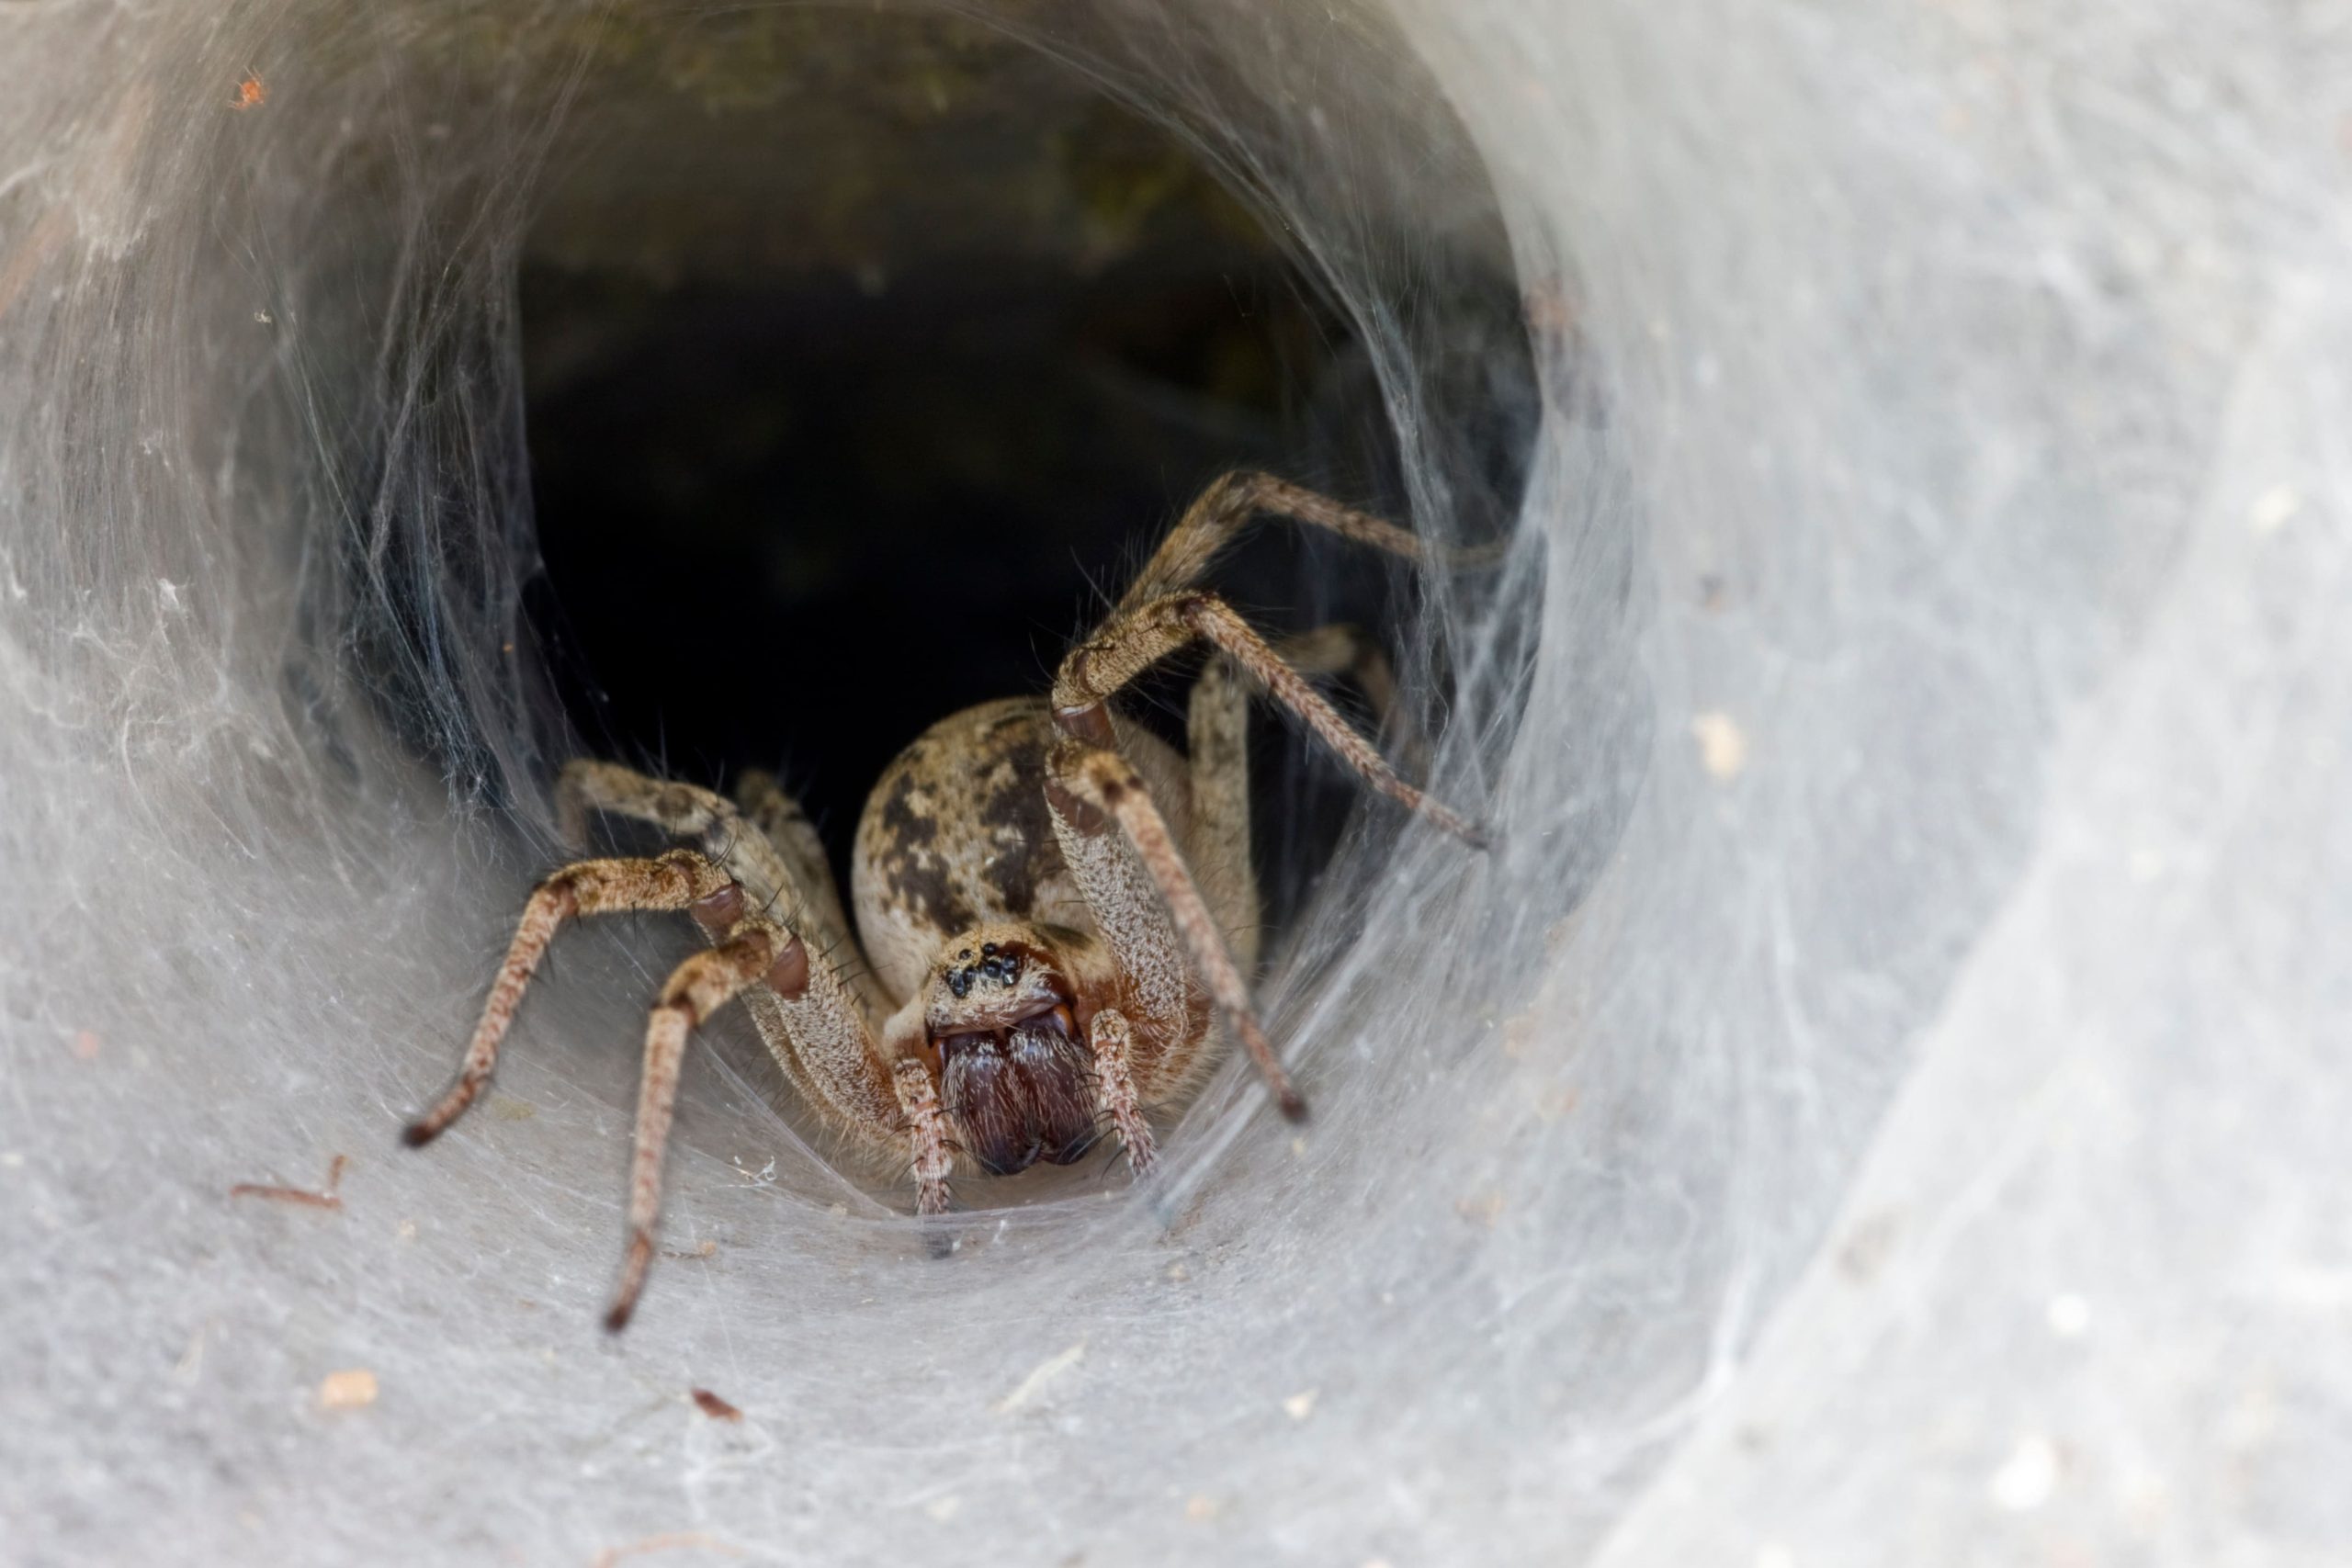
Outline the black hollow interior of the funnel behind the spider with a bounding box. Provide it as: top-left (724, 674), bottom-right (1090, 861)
top-left (522, 85), bottom-right (1526, 919)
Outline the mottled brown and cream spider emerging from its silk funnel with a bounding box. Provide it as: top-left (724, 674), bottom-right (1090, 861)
top-left (407, 472), bottom-right (1484, 1331)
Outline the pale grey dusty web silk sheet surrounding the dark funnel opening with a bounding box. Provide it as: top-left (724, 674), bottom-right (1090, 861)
top-left (0, 0), bottom-right (2352, 1568)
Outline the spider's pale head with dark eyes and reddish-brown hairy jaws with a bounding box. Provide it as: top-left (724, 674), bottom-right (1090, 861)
top-left (924, 924), bottom-right (1096, 1176)
